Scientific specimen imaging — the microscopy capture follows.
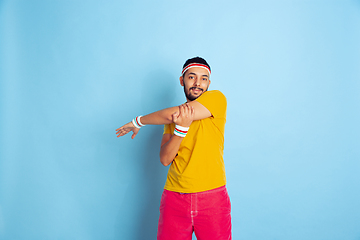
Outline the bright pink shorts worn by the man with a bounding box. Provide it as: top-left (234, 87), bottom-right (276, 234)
top-left (157, 186), bottom-right (232, 240)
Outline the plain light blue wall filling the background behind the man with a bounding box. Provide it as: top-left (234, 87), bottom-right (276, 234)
top-left (0, 0), bottom-right (360, 240)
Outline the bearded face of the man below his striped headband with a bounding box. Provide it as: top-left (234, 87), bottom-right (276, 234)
top-left (180, 67), bottom-right (210, 102)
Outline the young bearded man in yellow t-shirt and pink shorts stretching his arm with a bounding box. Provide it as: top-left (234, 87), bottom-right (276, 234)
top-left (116, 57), bottom-right (231, 240)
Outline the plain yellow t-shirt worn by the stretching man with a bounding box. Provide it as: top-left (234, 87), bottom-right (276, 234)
top-left (164, 90), bottom-right (226, 193)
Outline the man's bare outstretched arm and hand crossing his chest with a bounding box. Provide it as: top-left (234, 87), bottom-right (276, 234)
top-left (116, 101), bottom-right (211, 139)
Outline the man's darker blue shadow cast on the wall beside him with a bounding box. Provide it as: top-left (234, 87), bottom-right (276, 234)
top-left (115, 71), bottom-right (177, 240)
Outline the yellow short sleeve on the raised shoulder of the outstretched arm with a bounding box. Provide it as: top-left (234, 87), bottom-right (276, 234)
top-left (195, 90), bottom-right (227, 118)
